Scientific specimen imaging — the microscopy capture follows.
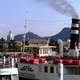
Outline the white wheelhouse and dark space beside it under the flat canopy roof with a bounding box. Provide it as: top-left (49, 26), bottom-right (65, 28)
top-left (25, 46), bottom-right (56, 57)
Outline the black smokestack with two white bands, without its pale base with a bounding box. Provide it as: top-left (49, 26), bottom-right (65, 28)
top-left (70, 19), bottom-right (80, 49)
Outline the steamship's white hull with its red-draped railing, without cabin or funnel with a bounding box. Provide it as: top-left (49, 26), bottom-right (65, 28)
top-left (18, 57), bottom-right (80, 80)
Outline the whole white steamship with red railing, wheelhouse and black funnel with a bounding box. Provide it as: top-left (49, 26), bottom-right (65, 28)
top-left (18, 19), bottom-right (80, 80)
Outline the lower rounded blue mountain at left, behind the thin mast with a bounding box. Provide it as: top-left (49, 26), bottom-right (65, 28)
top-left (15, 32), bottom-right (41, 41)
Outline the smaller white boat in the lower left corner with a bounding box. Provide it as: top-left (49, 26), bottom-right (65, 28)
top-left (0, 56), bottom-right (19, 80)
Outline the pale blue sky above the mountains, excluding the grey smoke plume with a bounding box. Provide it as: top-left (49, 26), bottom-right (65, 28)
top-left (0, 0), bottom-right (80, 38)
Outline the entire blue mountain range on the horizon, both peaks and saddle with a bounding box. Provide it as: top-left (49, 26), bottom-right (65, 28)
top-left (15, 28), bottom-right (70, 41)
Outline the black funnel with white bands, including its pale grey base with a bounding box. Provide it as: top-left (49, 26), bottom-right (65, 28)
top-left (69, 19), bottom-right (80, 57)
